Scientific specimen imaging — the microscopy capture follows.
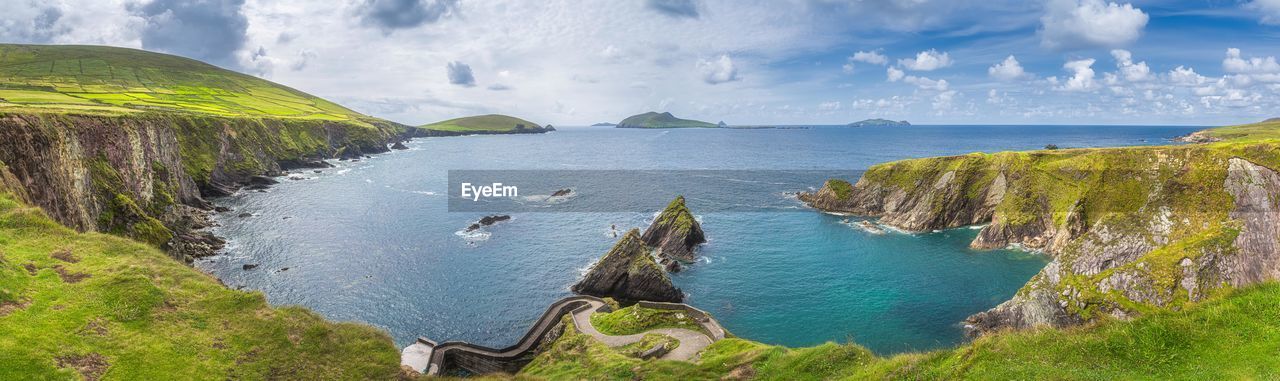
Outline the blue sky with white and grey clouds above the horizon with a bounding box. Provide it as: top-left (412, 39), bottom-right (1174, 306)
top-left (0, 0), bottom-right (1280, 125)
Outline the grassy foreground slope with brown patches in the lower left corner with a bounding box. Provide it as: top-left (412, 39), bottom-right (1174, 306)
top-left (0, 189), bottom-right (399, 380)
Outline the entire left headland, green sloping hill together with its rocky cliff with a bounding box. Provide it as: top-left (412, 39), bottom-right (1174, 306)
top-left (0, 45), bottom-right (413, 261)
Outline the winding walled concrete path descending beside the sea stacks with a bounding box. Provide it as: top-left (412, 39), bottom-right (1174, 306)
top-left (401, 297), bottom-right (724, 375)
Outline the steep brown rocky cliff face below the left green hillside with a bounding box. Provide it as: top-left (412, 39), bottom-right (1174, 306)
top-left (0, 113), bottom-right (404, 261)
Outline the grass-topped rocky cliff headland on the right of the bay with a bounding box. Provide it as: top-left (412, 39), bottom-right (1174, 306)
top-left (800, 127), bottom-right (1280, 331)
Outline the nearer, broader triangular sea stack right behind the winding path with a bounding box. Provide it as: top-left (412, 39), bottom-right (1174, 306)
top-left (572, 229), bottom-right (685, 303)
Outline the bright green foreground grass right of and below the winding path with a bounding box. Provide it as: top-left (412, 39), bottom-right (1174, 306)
top-left (520, 284), bottom-right (1280, 380)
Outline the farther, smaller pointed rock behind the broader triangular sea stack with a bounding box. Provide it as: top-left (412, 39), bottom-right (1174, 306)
top-left (641, 196), bottom-right (707, 262)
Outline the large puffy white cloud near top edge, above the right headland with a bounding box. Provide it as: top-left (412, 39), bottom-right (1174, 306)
top-left (1039, 0), bottom-right (1149, 50)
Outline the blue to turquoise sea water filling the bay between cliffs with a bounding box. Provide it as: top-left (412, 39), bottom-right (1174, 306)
top-left (197, 125), bottom-right (1198, 354)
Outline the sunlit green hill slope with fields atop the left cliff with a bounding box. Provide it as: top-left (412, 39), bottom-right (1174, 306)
top-left (0, 43), bottom-right (369, 120)
